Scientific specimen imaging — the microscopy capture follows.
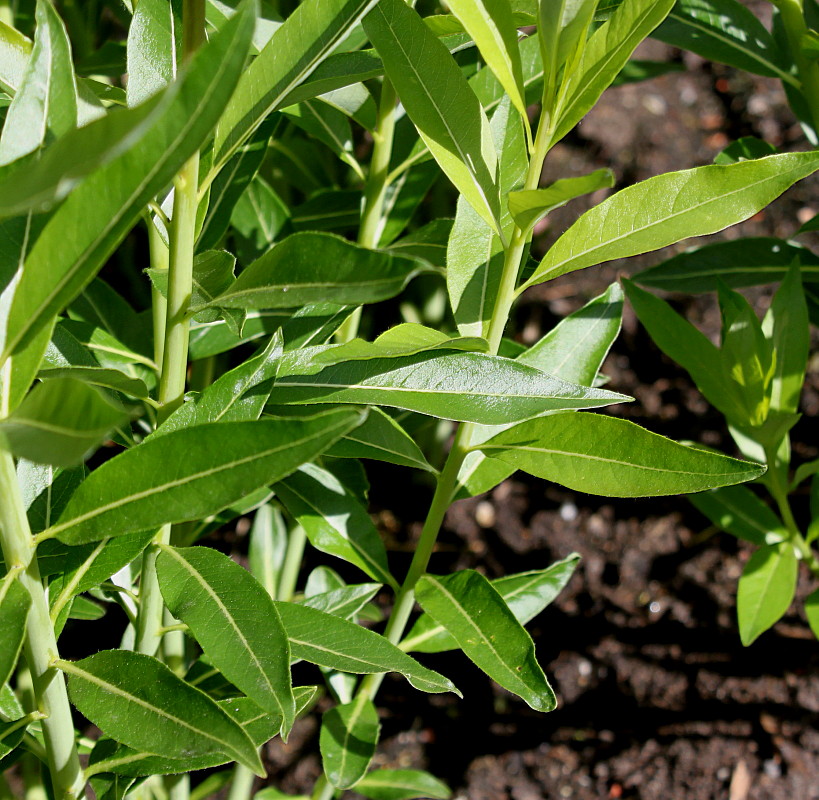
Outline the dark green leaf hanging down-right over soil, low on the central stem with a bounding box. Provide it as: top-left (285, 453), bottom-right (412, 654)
top-left (415, 570), bottom-right (557, 711)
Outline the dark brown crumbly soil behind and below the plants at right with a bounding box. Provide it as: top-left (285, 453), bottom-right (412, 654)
top-left (255, 26), bottom-right (819, 800)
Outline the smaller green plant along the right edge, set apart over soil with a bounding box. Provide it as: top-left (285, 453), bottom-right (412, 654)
top-left (616, 0), bottom-right (819, 645)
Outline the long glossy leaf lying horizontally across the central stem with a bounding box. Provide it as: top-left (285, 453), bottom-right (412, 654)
top-left (270, 350), bottom-right (626, 425)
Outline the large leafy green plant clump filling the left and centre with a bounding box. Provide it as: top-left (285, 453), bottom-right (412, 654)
top-left (0, 0), bottom-right (819, 800)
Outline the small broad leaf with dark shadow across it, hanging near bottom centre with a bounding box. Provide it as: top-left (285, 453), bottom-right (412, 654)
top-left (319, 695), bottom-right (381, 789)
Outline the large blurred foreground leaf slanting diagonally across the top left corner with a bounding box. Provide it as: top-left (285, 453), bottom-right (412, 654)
top-left (2, 4), bottom-right (254, 359)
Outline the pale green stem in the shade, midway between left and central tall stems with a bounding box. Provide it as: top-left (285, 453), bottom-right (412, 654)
top-left (336, 78), bottom-right (398, 342)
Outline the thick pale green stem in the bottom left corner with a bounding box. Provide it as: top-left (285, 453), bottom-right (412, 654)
top-left (0, 446), bottom-right (83, 800)
